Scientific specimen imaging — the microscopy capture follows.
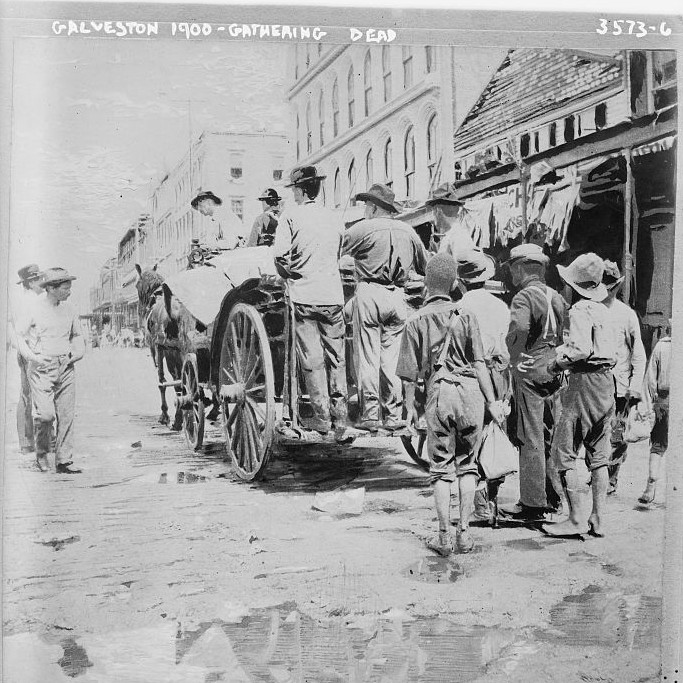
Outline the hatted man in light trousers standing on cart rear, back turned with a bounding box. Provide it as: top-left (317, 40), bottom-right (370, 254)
top-left (343, 184), bottom-right (427, 432)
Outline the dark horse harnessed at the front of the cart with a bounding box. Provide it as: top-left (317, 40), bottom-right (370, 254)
top-left (135, 263), bottom-right (183, 431)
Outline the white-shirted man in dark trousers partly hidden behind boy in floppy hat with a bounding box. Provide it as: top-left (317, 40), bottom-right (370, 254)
top-left (602, 261), bottom-right (647, 495)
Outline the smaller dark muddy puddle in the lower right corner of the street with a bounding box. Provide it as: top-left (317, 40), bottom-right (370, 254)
top-left (538, 586), bottom-right (662, 649)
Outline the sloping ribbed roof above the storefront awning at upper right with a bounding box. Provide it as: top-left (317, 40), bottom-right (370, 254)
top-left (454, 48), bottom-right (622, 150)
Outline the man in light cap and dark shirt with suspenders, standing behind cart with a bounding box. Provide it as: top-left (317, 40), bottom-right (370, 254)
top-left (501, 244), bottom-right (567, 522)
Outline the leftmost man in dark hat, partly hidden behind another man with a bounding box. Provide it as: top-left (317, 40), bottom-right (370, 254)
top-left (9, 263), bottom-right (45, 454)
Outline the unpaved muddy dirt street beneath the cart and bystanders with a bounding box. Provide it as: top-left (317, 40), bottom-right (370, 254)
top-left (3, 349), bottom-right (664, 683)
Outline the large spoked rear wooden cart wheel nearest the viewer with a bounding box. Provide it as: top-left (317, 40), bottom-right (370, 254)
top-left (219, 303), bottom-right (275, 481)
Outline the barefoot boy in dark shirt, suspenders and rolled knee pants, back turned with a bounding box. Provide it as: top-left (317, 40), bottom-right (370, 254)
top-left (396, 254), bottom-right (505, 555)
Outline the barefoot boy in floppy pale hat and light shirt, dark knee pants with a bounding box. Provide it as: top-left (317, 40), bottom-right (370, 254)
top-left (545, 253), bottom-right (617, 537)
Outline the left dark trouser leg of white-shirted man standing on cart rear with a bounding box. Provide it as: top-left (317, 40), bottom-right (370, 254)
top-left (294, 303), bottom-right (330, 422)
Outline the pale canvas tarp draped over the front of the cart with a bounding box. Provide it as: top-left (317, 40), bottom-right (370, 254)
top-left (164, 247), bottom-right (276, 327)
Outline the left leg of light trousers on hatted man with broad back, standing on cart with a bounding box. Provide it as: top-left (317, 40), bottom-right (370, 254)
top-left (353, 282), bottom-right (382, 421)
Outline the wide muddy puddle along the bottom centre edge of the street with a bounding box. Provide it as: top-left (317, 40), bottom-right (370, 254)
top-left (176, 603), bottom-right (516, 683)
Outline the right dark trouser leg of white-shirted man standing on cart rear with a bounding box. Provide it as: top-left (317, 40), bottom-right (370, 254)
top-left (318, 306), bottom-right (348, 424)
